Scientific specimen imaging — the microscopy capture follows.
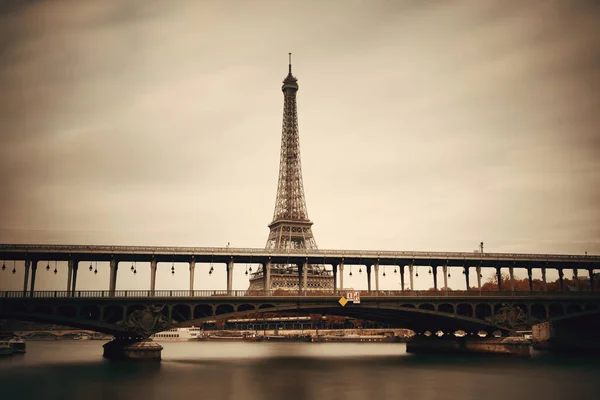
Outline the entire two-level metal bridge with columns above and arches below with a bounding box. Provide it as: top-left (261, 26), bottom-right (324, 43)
top-left (0, 245), bottom-right (600, 360)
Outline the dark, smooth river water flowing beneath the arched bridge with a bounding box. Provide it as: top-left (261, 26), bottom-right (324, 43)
top-left (0, 340), bottom-right (600, 400)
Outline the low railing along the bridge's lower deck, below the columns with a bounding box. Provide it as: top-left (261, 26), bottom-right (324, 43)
top-left (0, 290), bottom-right (600, 299)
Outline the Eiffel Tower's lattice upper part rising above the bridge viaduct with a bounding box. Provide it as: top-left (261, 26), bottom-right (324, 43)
top-left (266, 53), bottom-right (317, 249)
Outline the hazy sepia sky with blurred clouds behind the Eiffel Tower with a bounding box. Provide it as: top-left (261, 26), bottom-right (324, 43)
top-left (0, 0), bottom-right (600, 289)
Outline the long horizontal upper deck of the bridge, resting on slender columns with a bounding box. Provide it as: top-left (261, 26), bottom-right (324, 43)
top-left (0, 244), bottom-right (600, 268)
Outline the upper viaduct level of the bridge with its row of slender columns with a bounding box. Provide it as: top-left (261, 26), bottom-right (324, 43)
top-left (0, 244), bottom-right (600, 294)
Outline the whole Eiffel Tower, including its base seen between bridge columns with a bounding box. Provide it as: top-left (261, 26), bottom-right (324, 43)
top-left (250, 53), bottom-right (333, 290)
